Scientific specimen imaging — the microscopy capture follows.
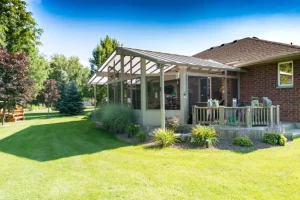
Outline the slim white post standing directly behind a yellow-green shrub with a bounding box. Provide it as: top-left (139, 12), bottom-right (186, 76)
top-left (159, 64), bottom-right (166, 129)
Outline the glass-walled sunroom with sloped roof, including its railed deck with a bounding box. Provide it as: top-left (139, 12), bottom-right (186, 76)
top-left (89, 47), bottom-right (279, 128)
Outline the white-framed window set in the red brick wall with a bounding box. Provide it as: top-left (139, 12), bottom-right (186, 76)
top-left (278, 61), bottom-right (294, 86)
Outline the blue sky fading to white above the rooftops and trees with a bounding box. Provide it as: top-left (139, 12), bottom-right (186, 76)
top-left (26, 0), bottom-right (300, 66)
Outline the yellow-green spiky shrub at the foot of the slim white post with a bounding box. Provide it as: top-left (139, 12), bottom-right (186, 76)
top-left (154, 128), bottom-right (176, 147)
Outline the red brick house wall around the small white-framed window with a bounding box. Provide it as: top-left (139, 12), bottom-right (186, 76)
top-left (240, 60), bottom-right (300, 122)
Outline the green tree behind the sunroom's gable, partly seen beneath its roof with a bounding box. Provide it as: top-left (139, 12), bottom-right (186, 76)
top-left (87, 35), bottom-right (122, 104)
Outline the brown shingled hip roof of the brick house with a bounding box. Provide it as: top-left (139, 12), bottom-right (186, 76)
top-left (194, 37), bottom-right (300, 66)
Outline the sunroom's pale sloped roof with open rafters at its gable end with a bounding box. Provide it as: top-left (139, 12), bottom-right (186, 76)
top-left (88, 47), bottom-right (245, 85)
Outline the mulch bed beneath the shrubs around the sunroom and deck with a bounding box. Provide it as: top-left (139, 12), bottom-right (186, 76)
top-left (116, 134), bottom-right (291, 151)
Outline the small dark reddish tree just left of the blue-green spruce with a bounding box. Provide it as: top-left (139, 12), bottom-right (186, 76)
top-left (40, 79), bottom-right (60, 116)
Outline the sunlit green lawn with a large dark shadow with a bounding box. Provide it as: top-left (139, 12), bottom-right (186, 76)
top-left (0, 110), bottom-right (300, 200)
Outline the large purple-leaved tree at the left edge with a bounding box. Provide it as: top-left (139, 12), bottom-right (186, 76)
top-left (0, 48), bottom-right (34, 125)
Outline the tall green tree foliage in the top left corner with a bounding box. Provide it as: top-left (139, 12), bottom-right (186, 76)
top-left (0, 0), bottom-right (42, 53)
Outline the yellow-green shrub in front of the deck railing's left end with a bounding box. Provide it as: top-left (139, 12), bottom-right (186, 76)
top-left (191, 125), bottom-right (218, 146)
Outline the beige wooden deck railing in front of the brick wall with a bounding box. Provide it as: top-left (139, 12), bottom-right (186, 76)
top-left (193, 105), bottom-right (280, 127)
